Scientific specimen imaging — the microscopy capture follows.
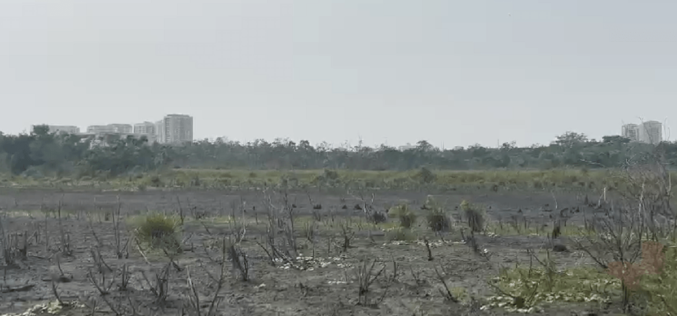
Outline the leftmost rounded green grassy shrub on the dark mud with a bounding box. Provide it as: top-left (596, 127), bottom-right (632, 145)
top-left (135, 214), bottom-right (181, 252)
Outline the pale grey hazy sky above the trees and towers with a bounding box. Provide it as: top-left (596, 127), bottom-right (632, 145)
top-left (0, 0), bottom-right (677, 147)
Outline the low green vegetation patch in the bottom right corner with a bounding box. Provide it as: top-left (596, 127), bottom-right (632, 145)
top-left (487, 241), bottom-right (677, 315)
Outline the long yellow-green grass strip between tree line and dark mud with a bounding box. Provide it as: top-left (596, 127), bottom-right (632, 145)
top-left (0, 168), bottom-right (648, 192)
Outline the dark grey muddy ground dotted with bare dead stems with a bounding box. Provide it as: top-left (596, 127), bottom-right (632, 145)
top-left (0, 190), bottom-right (611, 315)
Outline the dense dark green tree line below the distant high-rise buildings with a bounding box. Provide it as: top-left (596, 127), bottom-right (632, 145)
top-left (0, 125), bottom-right (677, 177)
